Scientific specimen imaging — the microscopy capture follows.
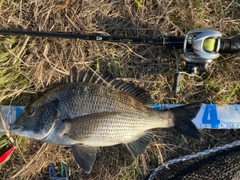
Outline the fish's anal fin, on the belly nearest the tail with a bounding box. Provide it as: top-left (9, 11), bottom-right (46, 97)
top-left (126, 131), bottom-right (153, 157)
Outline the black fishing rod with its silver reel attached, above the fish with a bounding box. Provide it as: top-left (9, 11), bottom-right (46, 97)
top-left (0, 29), bottom-right (240, 92)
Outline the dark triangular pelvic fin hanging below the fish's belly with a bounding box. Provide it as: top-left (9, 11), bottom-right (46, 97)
top-left (71, 145), bottom-right (97, 173)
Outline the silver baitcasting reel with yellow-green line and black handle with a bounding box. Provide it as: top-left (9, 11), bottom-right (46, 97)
top-left (173, 29), bottom-right (222, 92)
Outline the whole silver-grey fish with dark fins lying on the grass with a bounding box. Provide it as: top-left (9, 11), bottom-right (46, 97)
top-left (10, 70), bottom-right (201, 173)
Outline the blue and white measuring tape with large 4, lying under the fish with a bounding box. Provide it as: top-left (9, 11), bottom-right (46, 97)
top-left (0, 104), bottom-right (240, 135)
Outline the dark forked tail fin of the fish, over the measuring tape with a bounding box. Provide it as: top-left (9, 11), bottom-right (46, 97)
top-left (169, 103), bottom-right (201, 139)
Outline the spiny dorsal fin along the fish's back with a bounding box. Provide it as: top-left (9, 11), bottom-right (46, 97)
top-left (67, 68), bottom-right (155, 106)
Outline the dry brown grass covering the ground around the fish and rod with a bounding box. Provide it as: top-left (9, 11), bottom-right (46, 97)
top-left (0, 0), bottom-right (240, 179)
